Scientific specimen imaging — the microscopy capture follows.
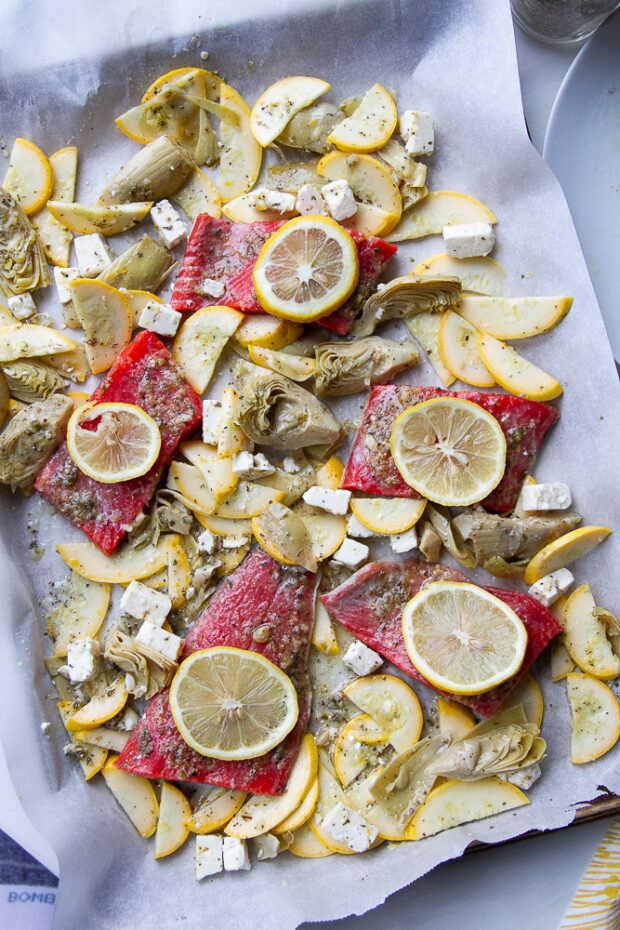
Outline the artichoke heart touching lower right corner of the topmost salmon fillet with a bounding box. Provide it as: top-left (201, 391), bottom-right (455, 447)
top-left (352, 274), bottom-right (461, 336)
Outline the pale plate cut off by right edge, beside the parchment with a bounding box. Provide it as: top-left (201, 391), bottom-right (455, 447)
top-left (543, 12), bottom-right (620, 360)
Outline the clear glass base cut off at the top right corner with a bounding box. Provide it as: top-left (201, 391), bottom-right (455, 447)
top-left (510, 0), bottom-right (620, 45)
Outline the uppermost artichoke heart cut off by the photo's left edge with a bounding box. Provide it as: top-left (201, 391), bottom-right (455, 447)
top-left (0, 187), bottom-right (50, 299)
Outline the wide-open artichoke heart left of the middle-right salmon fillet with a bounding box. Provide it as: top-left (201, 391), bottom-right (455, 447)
top-left (233, 361), bottom-right (344, 449)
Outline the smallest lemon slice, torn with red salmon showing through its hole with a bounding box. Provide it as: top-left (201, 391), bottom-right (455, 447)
top-left (67, 403), bottom-right (161, 484)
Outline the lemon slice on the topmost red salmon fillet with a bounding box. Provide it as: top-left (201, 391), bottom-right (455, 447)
top-left (254, 216), bottom-right (359, 322)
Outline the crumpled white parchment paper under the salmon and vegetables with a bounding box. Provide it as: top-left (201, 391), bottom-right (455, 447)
top-left (0, 0), bottom-right (620, 930)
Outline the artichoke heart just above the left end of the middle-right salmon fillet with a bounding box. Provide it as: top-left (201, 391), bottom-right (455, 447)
top-left (314, 336), bottom-right (420, 395)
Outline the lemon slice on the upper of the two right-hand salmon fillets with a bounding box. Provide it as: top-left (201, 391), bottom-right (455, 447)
top-left (390, 397), bottom-right (506, 507)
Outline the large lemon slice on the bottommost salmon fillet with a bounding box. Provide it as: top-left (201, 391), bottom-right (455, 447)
top-left (170, 646), bottom-right (299, 759)
